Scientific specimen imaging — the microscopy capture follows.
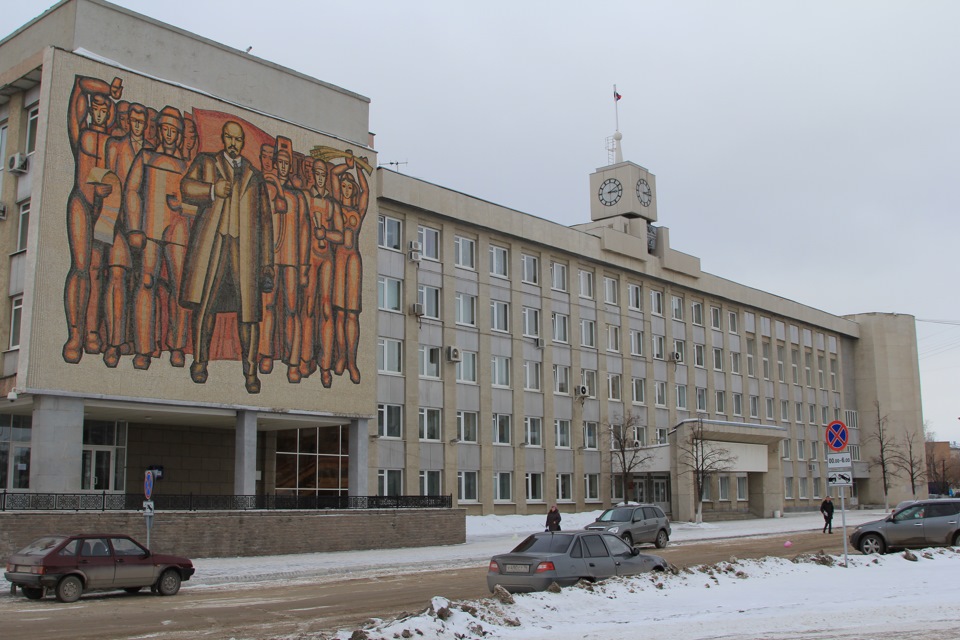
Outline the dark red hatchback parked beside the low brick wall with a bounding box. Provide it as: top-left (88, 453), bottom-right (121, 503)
top-left (3, 533), bottom-right (195, 602)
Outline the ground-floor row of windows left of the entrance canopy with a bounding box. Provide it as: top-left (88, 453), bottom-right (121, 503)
top-left (377, 469), bottom-right (600, 502)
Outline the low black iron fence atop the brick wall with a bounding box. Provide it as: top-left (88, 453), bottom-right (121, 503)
top-left (0, 491), bottom-right (453, 511)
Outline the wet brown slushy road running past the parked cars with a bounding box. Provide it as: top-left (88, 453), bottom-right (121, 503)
top-left (0, 532), bottom-right (859, 640)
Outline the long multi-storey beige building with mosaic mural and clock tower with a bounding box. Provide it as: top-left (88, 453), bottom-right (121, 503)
top-left (0, 0), bottom-right (922, 518)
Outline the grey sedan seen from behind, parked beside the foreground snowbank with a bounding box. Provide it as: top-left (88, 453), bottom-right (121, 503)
top-left (487, 531), bottom-right (667, 592)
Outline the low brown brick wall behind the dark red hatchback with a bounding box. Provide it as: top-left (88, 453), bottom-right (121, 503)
top-left (0, 509), bottom-right (466, 562)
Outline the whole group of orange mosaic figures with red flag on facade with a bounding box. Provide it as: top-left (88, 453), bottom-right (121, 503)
top-left (63, 75), bottom-right (372, 394)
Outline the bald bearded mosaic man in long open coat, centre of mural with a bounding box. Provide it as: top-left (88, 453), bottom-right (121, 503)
top-left (180, 121), bottom-right (273, 393)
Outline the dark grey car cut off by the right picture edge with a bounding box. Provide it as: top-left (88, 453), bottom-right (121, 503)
top-left (850, 500), bottom-right (960, 554)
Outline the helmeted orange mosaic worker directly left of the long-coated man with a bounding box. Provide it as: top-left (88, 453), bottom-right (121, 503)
top-left (124, 105), bottom-right (190, 369)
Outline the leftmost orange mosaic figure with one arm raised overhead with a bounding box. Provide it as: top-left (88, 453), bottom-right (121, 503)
top-left (63, 76), bottom-right (123, 363)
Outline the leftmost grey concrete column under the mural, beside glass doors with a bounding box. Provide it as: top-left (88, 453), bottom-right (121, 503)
top-left (30, 395), bottom-right (83, 493)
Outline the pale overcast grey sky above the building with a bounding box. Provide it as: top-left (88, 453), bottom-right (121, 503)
top-left (0, 0), bottom-right (960, 441)
